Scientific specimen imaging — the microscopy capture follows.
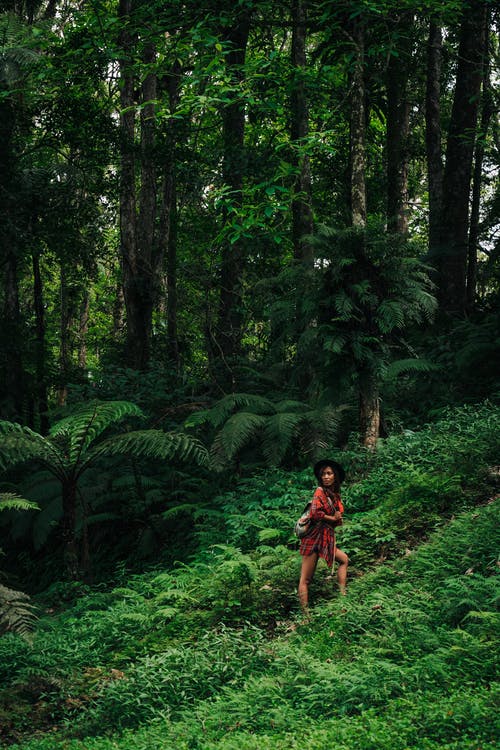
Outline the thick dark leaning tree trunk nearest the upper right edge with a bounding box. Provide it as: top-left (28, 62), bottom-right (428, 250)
top-left (436, 0), bottom-right (486, 315)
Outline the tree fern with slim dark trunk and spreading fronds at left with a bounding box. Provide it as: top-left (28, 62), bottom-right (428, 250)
top-left (0, 401), bottom-right (207, 580)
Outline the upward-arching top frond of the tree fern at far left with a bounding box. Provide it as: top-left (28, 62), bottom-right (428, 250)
top-left (50, 401), bottom-right (144, 463)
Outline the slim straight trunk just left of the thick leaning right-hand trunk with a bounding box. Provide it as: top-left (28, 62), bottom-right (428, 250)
top-left (425, 21), bottom-right (443, 257)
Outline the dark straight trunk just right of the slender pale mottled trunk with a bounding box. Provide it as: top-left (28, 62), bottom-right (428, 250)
top-left (387, 14), bottom-right (413, 234)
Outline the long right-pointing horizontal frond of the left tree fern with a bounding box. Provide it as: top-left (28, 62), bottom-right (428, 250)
top-left (86, 430), bottom-right (209, 466)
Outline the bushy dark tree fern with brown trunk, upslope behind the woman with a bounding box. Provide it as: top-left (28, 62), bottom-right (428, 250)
top-left (314, 226), bottom-right (435, 449)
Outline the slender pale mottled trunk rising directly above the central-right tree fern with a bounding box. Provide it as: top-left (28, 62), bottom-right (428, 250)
top-left (349, 18), bottom-right (366, 227)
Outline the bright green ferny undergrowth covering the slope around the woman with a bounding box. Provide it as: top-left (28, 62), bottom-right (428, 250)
top-left (0, 407), bottom-right (499, 750)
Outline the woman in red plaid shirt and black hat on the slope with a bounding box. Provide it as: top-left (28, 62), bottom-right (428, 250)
top-left (298, 459), bottom-right (349, 613)
